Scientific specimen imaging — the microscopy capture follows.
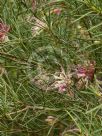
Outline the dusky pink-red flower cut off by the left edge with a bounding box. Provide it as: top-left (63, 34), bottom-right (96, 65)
top-left (0, 22), bottom-right (10, 41)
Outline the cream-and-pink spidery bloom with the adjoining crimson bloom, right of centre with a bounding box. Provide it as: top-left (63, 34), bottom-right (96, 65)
top-left (54, 62), bottom-right (95, 93)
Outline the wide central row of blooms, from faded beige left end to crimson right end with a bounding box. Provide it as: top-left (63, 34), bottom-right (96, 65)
top-left (32, 62), bottom-right (95, 96)
